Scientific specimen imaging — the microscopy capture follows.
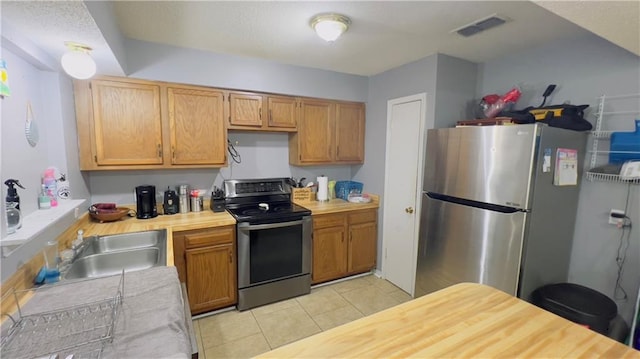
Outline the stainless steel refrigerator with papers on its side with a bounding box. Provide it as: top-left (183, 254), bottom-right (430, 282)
top-left (415, 124), bottom-right (587, 300)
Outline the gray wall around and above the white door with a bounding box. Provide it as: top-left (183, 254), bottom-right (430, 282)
top-left (354, 54), bottom-right (477, 265)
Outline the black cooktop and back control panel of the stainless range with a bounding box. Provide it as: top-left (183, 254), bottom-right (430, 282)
top-left (224, 178), bottom-right (311, 224)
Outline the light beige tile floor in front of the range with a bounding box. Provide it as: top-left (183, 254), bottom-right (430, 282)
top-left (193, 275), bottom-right (411, 359)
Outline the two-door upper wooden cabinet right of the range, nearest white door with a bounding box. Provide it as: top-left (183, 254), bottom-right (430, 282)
top-left (289, 99), bottom-right (364, 166)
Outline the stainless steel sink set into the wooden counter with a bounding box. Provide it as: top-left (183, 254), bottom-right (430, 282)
top-left (64, 230), bottom-right (167, 279)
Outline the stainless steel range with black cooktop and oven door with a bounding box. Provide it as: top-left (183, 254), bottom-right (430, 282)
top-left (224, 178), bottom-right (312, 310)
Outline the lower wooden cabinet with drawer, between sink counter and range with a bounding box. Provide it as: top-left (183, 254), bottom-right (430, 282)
top-left (173, 226), bottom-right (238, 314)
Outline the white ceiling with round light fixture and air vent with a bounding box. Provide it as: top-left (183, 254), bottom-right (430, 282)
top-left (0, 0), bottom-right (640, 76)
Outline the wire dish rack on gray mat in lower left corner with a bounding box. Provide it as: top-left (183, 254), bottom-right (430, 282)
top-left (0, 271), bottom-right (124, 359)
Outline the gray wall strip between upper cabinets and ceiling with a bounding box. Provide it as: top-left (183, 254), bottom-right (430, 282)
top-left (125, 39), bottom-right (368, 102)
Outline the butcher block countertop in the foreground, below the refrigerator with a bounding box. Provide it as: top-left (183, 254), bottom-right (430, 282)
top-left (252, 283), bottom-right (640, 358)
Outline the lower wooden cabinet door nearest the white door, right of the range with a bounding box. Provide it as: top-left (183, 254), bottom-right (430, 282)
top-left (348, 222), bottom-right (378, 273)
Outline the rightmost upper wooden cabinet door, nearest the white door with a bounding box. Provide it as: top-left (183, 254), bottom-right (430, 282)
top-left (336, 103), bottom-right (364, 163)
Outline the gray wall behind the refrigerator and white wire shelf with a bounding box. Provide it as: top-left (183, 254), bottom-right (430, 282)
top-left (477, 35), bottom-right (640, 323)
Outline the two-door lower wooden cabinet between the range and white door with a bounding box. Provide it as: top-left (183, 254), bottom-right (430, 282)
top-left (311, 209), bottom-right (378, 284)
